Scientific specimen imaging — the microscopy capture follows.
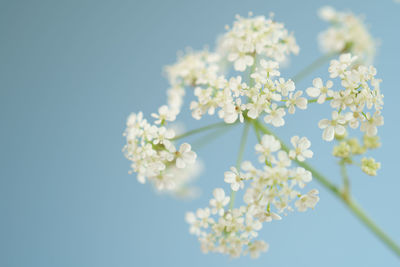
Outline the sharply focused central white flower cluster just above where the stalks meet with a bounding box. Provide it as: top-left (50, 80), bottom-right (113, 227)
top-left (190, 59), bottom-right (307, 127)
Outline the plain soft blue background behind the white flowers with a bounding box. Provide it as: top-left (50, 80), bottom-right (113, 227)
top-left (0, 0), bottom-right (400, 267)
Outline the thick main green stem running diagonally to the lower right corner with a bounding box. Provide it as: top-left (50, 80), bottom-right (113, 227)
top-left (253, 120), bottom-right (400, 257)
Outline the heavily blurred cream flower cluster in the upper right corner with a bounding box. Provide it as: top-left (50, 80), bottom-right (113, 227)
top-left (319, 7), bottom-right (376, 63)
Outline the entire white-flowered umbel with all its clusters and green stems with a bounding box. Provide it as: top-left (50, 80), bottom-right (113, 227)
top-left (123, 7), bottom-right (400, 257)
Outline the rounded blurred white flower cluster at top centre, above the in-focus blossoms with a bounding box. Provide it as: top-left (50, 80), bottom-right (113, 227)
top-left (218, 13), bottom-right (299, 71)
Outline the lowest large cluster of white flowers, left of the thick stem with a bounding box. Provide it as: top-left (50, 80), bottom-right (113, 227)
top-left (186, 135), bottom-right (319, 258)
